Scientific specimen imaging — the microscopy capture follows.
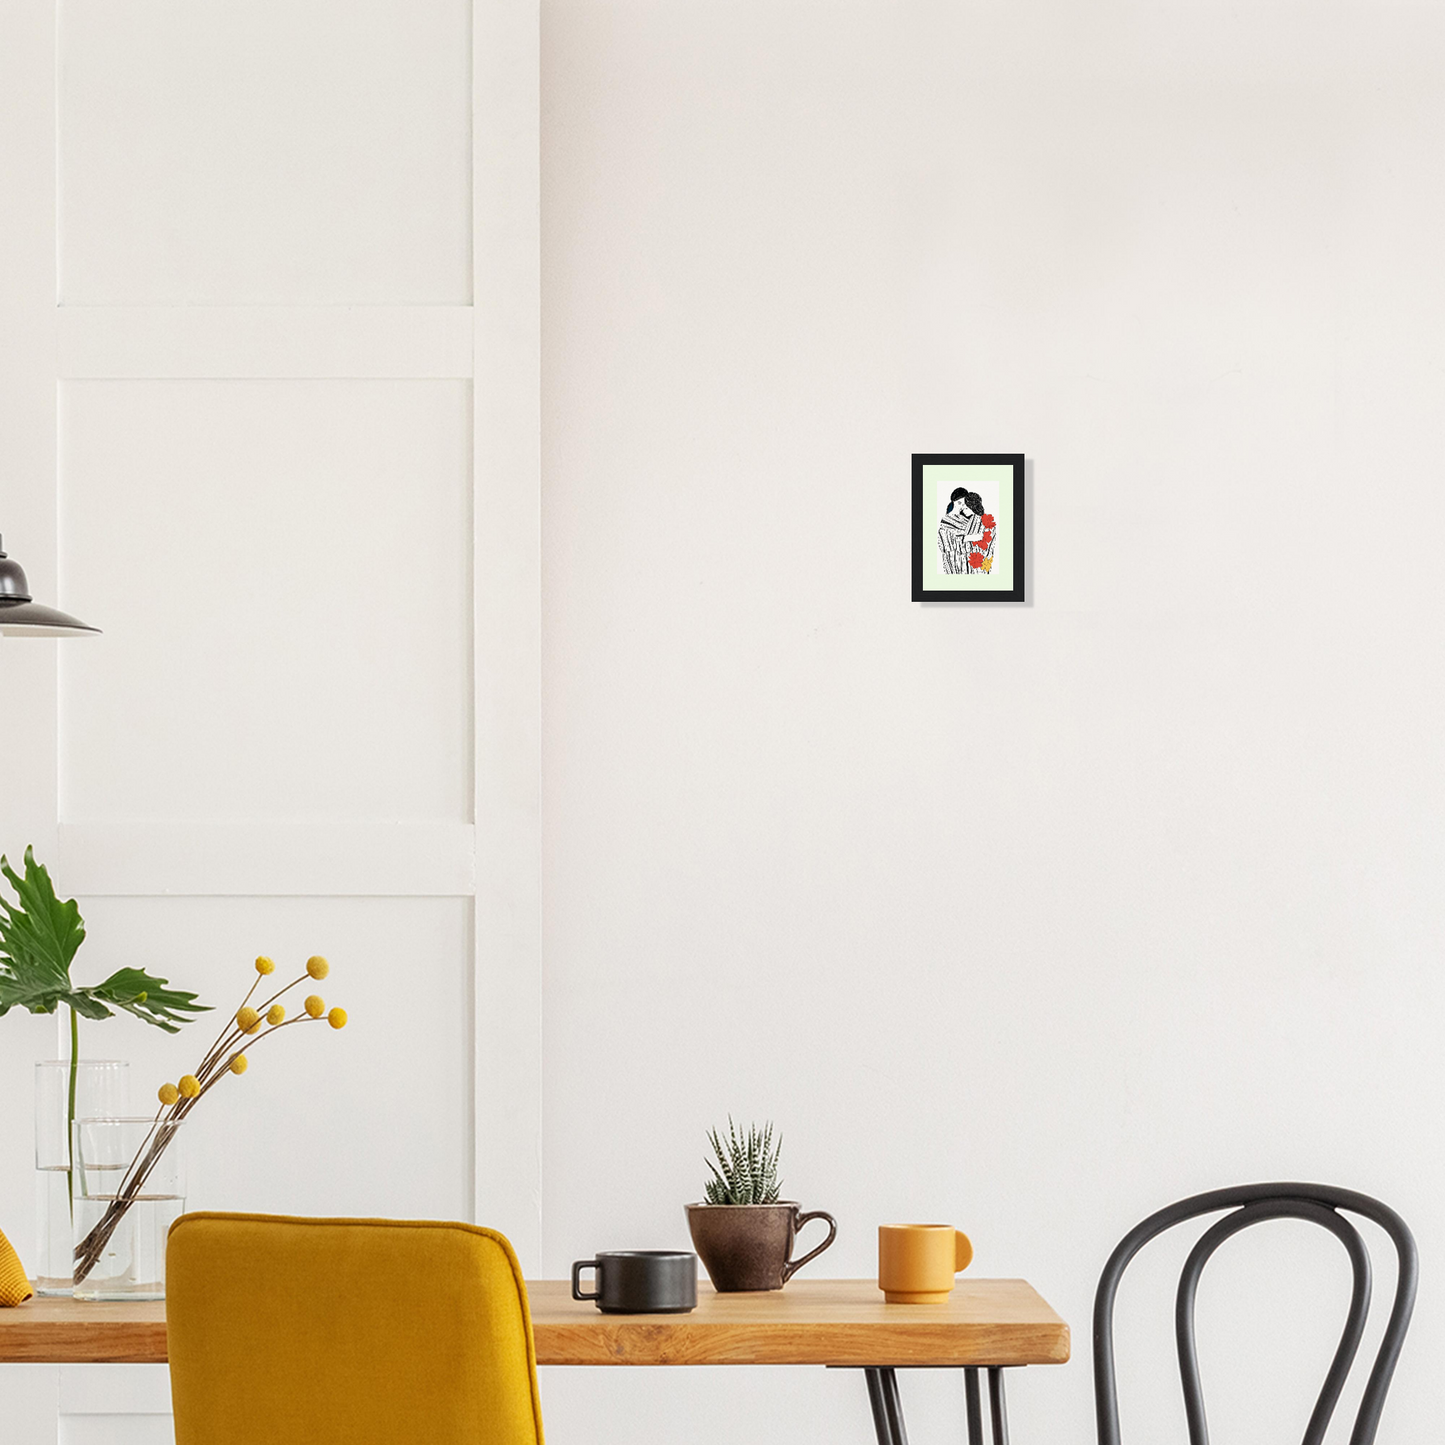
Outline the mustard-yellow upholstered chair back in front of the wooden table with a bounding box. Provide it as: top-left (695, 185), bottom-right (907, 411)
top-left (166, 1214), bottom-right (542, 1445)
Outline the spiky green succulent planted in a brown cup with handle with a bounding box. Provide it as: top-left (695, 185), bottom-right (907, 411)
top-left (686, 1114), bottom-right (838, 1293)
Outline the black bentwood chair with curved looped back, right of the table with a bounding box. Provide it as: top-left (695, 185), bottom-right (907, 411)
top-left (1094, 1183), bottom-right (1419, 1445)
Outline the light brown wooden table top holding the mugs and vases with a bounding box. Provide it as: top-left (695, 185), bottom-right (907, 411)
top-left (0, 1279), bottom-right (1069, 1366)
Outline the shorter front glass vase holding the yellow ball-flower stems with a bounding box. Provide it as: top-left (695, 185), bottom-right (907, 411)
top-left (72, 1117), bottom-right (185, 1299)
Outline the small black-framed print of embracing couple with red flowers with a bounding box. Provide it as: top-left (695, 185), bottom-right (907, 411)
top-left (913, 452), bottom-right (1023, 603)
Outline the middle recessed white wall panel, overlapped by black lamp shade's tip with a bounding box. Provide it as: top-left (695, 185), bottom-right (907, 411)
top-left (61, 380), bottom-right (471, 822)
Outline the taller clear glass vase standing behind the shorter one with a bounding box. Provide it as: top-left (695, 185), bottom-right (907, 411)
top-left (35, 1059), bottom-right (130, 1295)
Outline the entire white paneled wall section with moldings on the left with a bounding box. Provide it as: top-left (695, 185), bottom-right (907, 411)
top-left (0, 0), bottom-right (539, 1445)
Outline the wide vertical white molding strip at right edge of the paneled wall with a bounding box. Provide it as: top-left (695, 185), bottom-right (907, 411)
top-left (471, 0), bottom-right (542, 1272)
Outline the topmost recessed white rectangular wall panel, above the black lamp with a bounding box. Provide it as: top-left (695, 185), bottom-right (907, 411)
top-left (59, 0), bottom-right (471, 306)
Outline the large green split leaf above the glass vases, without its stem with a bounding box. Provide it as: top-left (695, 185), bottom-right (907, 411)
top-left (0, 848), bottom-right (207, 1033)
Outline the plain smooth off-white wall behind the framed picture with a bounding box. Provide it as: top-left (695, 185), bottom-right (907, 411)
top-left (543, 0), bottom-right (1445, 1445)
